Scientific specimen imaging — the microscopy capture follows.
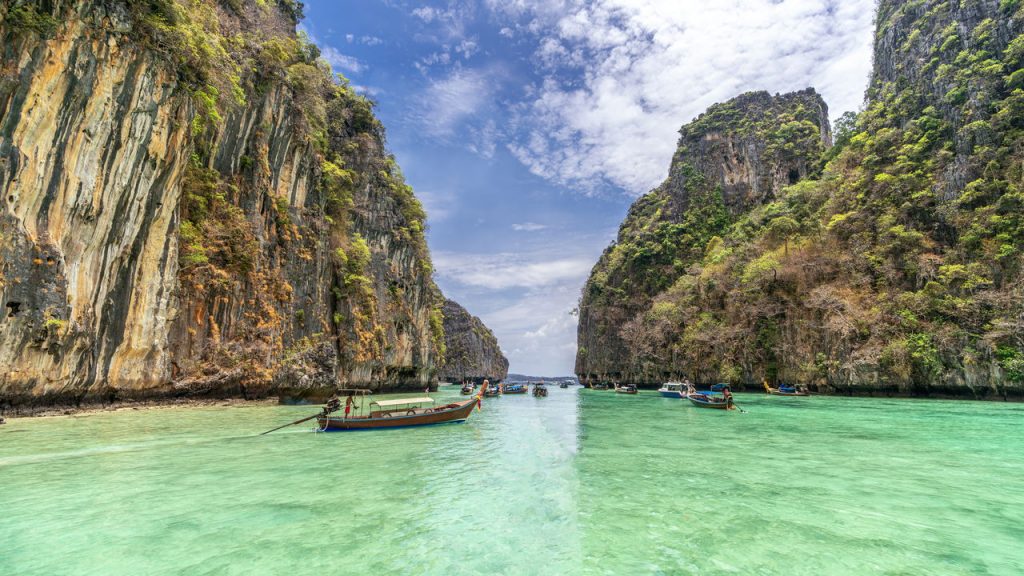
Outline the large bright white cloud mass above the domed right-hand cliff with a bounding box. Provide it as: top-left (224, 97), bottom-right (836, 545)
top-left (486, 0), bottom-right (874, 194)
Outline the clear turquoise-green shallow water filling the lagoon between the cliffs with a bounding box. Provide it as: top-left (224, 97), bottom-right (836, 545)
top-left (0, 387), bottom-right (1024, 576)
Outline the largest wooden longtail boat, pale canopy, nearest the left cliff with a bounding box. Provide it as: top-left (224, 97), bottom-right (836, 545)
top-left (316, 396), bottom-right (480, 431)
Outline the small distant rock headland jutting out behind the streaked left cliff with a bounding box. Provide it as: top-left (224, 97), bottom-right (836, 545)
top-left (440, 300), bottom-right (509, 383)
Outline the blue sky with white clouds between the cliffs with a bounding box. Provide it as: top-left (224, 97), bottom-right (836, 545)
top-left (300, 0), bottom-right (874, 375)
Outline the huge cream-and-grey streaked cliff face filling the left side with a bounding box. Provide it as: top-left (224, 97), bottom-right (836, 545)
top-left (0, 0), bottom-right (443, 406)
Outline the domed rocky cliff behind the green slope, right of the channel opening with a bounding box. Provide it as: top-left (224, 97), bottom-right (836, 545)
top-left (577, 89), bottom-right (830, 382)
